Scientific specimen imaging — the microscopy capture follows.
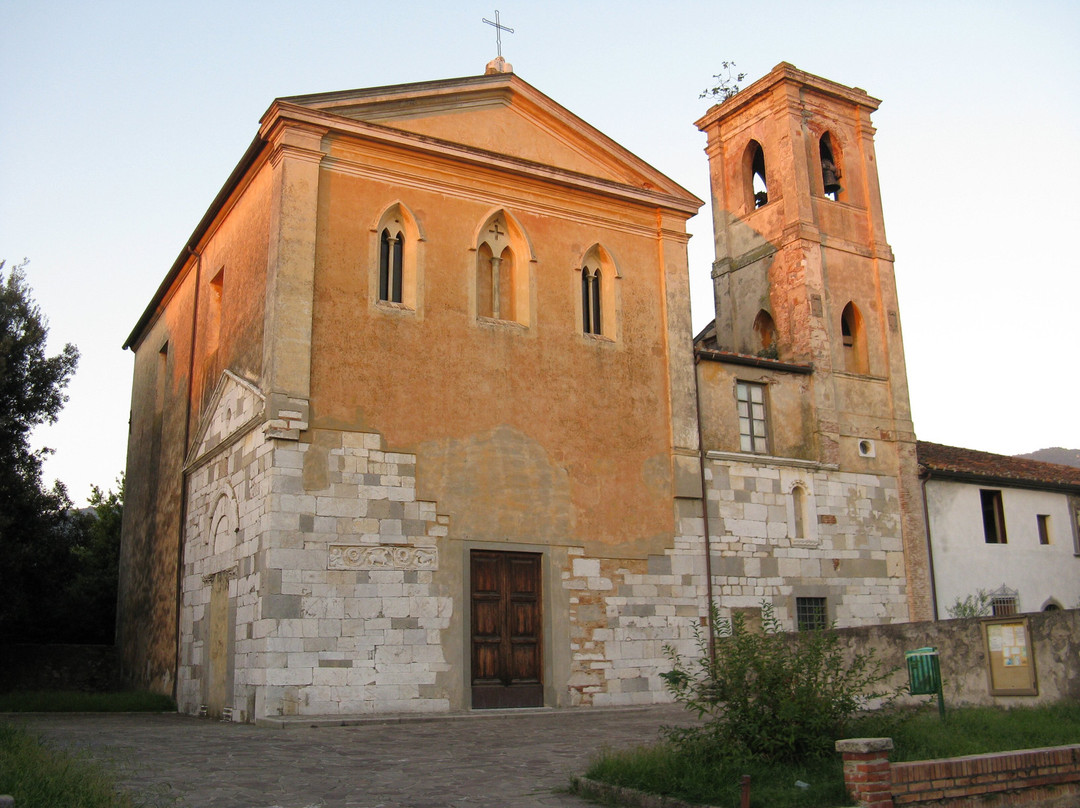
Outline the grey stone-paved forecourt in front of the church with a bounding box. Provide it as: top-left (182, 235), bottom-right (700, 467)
top-left (10, 704), bottom-right (692, 808)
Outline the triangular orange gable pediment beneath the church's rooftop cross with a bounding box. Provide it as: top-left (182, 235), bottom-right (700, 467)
top-left (279, 73), bottom-right (703, 206)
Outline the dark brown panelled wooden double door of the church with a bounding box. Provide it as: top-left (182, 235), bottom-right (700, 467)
top-left (470, 550), bottom-right (543, 709)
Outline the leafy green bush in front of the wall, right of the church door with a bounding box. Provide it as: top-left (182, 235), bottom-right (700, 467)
top-left (662, 602), bottom-right (901, 762)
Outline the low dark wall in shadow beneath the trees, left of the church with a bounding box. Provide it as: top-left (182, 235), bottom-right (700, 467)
top-left (0, 645), bottom-right (121, 692)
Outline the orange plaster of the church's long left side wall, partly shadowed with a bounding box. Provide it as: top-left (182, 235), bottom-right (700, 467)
top-left (117, 159), bottom-right (270, 693)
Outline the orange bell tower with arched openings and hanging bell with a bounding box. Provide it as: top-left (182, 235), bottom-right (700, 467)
top-left (697, 63), bottom-right (930, 619)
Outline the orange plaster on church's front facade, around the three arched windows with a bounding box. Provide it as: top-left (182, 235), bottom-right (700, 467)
top-left (312, 162), bottom-right (673, 555)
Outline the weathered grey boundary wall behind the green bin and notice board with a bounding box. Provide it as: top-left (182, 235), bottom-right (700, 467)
top-left (837, 609), bottom-right (1080, 706)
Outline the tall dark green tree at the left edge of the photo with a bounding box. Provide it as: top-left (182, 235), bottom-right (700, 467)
top-left (0, 260), bottom-right (79, 642)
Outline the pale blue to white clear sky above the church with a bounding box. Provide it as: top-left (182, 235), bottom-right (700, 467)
top-left (0, 0), bottom-right (1080, 501)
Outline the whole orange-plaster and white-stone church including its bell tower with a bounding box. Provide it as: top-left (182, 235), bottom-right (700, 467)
top-left (118, 59), bottom-right (930, 722)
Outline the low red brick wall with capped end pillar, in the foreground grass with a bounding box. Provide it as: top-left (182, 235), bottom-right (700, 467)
top-left (836, 738), bottom-right (1080, 808)
